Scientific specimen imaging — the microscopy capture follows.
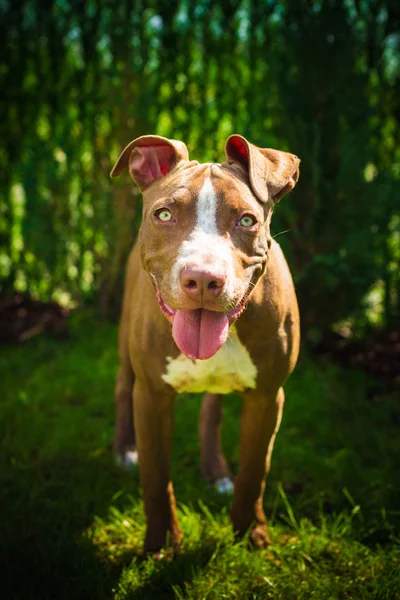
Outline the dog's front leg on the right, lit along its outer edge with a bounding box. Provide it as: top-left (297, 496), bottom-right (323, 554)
top-left (231, 388), bottom-right (285, 546)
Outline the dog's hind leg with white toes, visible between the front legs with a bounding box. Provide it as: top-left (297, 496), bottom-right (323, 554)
top-left (199, 393), bottom-right (233, 494)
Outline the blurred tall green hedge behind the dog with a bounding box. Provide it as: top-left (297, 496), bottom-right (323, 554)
top-left (0, 0), bottom-right (400, 329)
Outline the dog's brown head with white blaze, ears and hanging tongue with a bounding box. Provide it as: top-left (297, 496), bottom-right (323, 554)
top-left (111, 135), bottom-right (300, 359)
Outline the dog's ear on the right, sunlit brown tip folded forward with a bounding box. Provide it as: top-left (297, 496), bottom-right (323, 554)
top-left (225, 135), bottom-right (300, 203)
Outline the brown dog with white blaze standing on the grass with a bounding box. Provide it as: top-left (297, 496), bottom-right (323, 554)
top-left (111, 135), bottom-right (300, 551)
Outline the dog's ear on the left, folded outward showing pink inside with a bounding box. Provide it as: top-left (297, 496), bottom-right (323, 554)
top-left (110, 135), bottom-right (189, 190)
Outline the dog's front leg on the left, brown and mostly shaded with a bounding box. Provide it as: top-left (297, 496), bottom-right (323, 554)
top-left (133, 379), bottom-right (182, 552)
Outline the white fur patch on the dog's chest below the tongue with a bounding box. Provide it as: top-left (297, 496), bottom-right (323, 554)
top-left (162, 328), bottom-right (257, 394)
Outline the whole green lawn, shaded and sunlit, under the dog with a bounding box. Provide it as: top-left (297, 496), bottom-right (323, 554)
top-left (0, 313), bottom-right (400, 600)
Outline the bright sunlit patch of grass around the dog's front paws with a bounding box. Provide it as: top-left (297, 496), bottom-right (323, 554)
top-left (83, 497), bottom-right (400, 600)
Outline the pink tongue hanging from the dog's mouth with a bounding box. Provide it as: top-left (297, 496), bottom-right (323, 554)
top-left (172, 308), bottom-right (229, 359)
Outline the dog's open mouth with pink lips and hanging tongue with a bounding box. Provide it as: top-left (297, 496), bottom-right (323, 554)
top-left (156, 286), bottom-right (251, 360)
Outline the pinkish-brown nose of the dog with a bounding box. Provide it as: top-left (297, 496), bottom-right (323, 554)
top-left (179, 267), bottom-right (226, 302)
